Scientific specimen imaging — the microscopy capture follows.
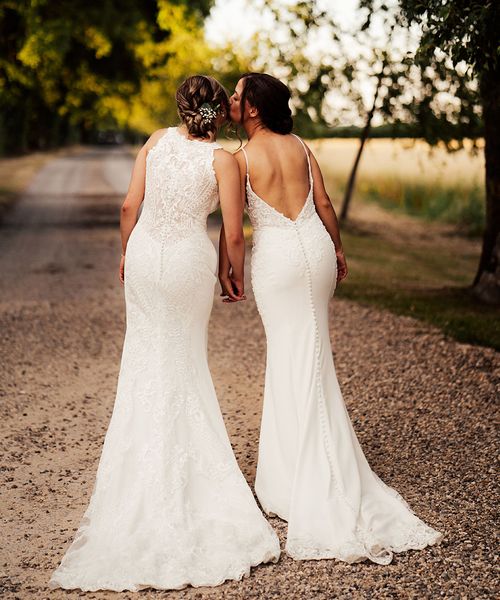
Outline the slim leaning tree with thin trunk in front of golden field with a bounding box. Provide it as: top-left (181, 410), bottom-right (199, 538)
top-left (340, 0), bottom-right (481, 220)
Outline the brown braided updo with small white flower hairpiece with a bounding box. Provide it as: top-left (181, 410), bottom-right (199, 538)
top-left (175, 75), bottom-right (229, 139)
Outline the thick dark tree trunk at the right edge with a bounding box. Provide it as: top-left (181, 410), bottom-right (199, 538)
top-left (473, 68), bottom-right (500, 304)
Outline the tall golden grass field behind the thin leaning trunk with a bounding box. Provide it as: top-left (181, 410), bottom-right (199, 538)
top-left (309, 139), bottom-right (484, 235)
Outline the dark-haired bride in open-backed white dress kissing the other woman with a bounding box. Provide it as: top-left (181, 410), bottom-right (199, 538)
top-left (219, 73), bottom-right (442, 564)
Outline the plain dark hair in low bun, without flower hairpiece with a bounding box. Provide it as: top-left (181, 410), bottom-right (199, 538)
top-left (241, 73), bottom-right (293, 134)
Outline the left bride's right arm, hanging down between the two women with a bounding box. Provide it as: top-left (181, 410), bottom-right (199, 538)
top-left (214, 149), bottom-right (245, 300)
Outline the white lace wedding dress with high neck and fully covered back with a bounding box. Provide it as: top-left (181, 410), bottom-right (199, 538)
top-left (49, 128), bottom-right (280, 591)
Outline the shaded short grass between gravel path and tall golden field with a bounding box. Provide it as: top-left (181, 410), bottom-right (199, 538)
top-left (337, 229), bottom-right (500, 350)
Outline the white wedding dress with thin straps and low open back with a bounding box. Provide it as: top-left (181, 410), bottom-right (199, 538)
top-left (243, 136), bottom-right (441, 564)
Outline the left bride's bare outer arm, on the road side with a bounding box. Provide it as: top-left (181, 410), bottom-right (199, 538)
top-left (120, 129), bottom-right (165, 283)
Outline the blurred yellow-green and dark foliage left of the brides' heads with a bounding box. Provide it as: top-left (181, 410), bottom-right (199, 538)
top-left (0, 0), bottom-right (217, 152)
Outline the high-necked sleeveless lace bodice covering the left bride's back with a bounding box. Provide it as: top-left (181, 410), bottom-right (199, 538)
top-left (140, 127), bottom-right (222, 242)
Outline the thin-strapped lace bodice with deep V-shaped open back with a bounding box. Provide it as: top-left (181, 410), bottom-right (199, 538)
top-left (242, 134), bottom-right (316, 230)
